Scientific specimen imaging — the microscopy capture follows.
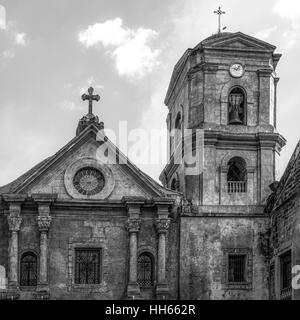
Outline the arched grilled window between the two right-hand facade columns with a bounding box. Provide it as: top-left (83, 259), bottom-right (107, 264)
top-left (137, 253), bottom-right (154, 288)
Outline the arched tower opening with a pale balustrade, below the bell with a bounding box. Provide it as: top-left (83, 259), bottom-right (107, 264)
top-left (227, 157), bottom-right (247, 193)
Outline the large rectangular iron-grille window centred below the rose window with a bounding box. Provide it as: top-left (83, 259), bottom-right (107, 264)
top-left (75, 249), bottom-right (102, 284)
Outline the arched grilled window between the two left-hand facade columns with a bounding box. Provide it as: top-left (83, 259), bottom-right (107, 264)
top-left (20, 252), bottom-right (37, 287)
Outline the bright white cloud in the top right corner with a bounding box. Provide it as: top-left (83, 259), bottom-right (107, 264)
top-left (274, 0), bottom-right (300, 29)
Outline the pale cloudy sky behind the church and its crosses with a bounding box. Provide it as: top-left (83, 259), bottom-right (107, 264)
top-left (0, 0), bottom-right (300, 185)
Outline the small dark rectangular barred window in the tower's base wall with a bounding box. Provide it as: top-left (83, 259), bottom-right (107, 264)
top-left (228, 254), bottom-right (247, 283)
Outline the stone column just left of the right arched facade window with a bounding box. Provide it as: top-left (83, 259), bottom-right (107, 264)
top-left (127, 219), bottom-right (141, 298)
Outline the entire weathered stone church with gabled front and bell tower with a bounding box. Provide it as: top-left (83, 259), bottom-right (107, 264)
top-left (0, 32), bottom-right (300, 300)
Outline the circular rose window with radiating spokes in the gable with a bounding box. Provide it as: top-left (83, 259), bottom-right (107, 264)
top-left (73, 167), bottom-right (105, 196)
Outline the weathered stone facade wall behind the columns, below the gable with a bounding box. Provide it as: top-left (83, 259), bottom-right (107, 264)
top-left (4, 208), bottom-right (178, 299)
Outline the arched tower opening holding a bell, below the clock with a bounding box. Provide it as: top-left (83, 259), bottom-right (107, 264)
top-left (228, 87), bottom-right (247, 125)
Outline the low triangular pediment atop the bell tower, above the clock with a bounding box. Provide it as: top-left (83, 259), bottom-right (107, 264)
top-left (199, 32), bottom-right (276, 52)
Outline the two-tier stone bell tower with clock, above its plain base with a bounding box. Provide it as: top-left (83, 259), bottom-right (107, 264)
top-left (160, 32), bottom-right (285, 211)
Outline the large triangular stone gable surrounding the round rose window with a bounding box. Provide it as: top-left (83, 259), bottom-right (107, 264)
top-left (0, 125), bottom-right (176, 200)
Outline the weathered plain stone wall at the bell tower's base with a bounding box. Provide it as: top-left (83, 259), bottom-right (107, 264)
top-left (180, 217), bottom-right (269, 300)
